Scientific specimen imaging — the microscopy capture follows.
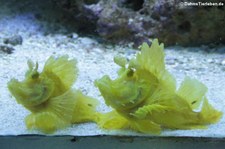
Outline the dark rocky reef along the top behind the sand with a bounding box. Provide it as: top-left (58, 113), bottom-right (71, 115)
top-left (53, 0), bottom-right (225, 46)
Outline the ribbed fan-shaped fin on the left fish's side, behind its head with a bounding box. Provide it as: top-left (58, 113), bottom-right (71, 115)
top-left (46, 89), bottom-right (76, 122)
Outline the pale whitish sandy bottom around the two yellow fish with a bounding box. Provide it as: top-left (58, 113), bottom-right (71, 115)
top-left (0, 0), bottom-right (225, 137)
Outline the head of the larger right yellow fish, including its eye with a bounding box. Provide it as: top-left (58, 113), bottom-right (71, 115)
top-left (95, 68), bottom-right (144, 111)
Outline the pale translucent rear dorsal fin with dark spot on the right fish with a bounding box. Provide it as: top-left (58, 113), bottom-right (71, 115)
top-left (177, 77), bottom-right (207, 109)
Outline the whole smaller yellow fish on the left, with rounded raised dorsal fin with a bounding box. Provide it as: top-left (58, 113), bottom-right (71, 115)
top-left (8, 56), bottom-right (97, 133)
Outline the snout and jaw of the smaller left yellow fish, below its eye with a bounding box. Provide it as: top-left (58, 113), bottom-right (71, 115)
top-left (8, 79), bottom-right (53, 107)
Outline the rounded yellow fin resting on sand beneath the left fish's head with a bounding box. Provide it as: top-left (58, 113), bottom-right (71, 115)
top-left (25, 112), bottom-right (69, 133)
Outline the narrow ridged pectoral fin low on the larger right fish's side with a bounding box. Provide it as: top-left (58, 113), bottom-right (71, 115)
top-left (132, 104), bottom-right (170, 119)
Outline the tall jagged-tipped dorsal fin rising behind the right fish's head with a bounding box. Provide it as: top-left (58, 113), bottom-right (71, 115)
top-left (134, 39), bottom-right (176, 90)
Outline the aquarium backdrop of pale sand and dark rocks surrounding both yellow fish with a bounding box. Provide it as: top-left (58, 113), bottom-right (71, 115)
top-left (0, 0), bottom-right (225, 137)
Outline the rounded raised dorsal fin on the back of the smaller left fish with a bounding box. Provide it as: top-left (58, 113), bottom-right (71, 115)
top-left (43, 55), bottom-right (78, 88)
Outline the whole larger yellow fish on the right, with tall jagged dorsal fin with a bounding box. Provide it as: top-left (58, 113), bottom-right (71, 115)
top-left (95, 39), bottom-right (222, 134)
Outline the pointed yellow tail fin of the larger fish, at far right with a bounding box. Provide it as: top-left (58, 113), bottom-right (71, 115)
top-left (200, 97), bottom-right (223, 124)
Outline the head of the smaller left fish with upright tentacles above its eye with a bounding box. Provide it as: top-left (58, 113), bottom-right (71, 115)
top-left (8, 61), bottom-right (54, 107)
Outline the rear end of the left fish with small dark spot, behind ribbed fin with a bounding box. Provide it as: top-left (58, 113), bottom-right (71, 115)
top-left (72, 91), bottom-right (99, 123)
